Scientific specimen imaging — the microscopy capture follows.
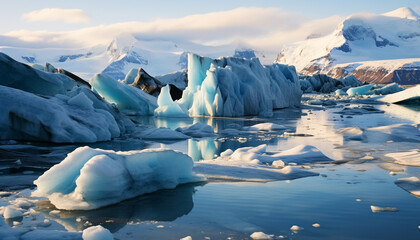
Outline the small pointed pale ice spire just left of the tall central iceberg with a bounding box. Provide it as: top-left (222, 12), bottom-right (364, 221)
top-left (155, 85), bottom-right (188, 117)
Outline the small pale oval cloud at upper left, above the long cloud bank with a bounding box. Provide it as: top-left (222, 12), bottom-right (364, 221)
top-left (22, 8), bottom-right (89, 23)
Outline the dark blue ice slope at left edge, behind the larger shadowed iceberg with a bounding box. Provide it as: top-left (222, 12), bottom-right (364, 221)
top-left (0, 52), bottom-right (76, 96)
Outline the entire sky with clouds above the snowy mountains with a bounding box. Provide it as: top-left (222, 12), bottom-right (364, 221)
top-left (0, 0), bottom-right (420, 50)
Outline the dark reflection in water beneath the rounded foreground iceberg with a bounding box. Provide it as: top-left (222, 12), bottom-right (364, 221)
top-left (37, 183), bottom-right (204, 232)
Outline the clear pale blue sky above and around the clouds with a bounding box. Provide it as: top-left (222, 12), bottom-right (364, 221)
top-left (0, 0), bottom-right (420, 34)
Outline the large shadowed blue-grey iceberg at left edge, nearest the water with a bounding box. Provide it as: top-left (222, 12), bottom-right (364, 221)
top-left (0, 86), bottom-right (134, 143)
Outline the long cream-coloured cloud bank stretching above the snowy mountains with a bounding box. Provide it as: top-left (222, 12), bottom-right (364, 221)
top-left (4, 7), bottom-right (341, 51)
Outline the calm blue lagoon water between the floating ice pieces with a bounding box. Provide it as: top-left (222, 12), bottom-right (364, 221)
top-left (0, 98), bottom-right (420, 239)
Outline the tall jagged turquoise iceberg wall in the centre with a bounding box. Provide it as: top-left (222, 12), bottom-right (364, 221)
top-left (159, 54), bottom-right (302, 116)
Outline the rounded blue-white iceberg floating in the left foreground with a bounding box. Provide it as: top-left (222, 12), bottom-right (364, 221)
top-left (33, 147), bottom-right (200, 210)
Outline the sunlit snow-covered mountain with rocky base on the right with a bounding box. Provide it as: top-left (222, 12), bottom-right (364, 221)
top-left (276, 7), bottom-right (420, 84)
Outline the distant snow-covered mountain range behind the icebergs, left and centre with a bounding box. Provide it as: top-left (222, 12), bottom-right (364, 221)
top-left (0, 35), bottom-right (264, 79)
